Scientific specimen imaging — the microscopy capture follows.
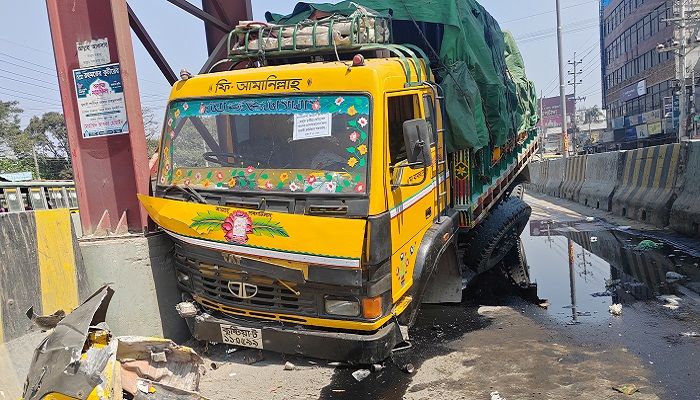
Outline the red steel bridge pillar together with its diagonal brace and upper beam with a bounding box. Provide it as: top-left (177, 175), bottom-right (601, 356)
top-left (46, 0), bottom-right (252, 236)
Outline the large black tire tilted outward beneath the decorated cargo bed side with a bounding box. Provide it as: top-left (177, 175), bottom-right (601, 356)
top-left (464, 197), bottom-right (532, 274)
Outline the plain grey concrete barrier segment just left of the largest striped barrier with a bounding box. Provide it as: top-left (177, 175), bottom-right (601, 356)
top-left (578, 151), bottom-right (625, 211)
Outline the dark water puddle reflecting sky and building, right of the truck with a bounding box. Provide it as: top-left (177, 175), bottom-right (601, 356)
top-left (522, 220), bottom-right (700, 323)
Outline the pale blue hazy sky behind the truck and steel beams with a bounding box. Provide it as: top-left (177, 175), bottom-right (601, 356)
top-left (0, 0), bottom-right (601, 126)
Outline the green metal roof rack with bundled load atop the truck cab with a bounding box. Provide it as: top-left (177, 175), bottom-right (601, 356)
top-left (210, 12), bottom-right (430, 86)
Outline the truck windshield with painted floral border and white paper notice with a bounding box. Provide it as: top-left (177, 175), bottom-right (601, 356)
top-left (158, 95), bottom-right (370, 193)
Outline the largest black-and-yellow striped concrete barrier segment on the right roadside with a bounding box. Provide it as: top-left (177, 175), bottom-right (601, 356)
top-left (613, 143), bottom-right (683, 227)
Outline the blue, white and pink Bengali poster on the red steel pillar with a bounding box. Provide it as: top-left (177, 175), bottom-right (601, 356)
top-left (73, 63), bottom-right (129, 139)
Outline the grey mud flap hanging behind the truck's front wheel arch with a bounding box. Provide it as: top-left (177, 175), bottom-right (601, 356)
top-left (421, 246), bottom-right (462, 304)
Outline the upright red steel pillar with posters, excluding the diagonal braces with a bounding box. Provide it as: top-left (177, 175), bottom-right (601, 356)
top-left (46, 0), bottom-right (149, 236)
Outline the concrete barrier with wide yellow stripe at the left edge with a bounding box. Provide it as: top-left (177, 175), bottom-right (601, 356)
top-left (0, 209), bottom-right (90, 398)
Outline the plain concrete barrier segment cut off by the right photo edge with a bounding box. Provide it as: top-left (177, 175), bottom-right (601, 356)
top-left (670, 142), bottom-right (700, 237)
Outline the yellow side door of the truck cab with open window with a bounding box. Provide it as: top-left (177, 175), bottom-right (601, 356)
top-left (385, 90), bottom-right (436, 301)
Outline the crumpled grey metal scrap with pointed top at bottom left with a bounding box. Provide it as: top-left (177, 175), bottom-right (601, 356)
top-left (23, 286), bottom-right (114, 400)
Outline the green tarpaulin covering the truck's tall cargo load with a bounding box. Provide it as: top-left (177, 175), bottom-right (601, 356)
top-left (266, 0), bottom-right (537, 151)
